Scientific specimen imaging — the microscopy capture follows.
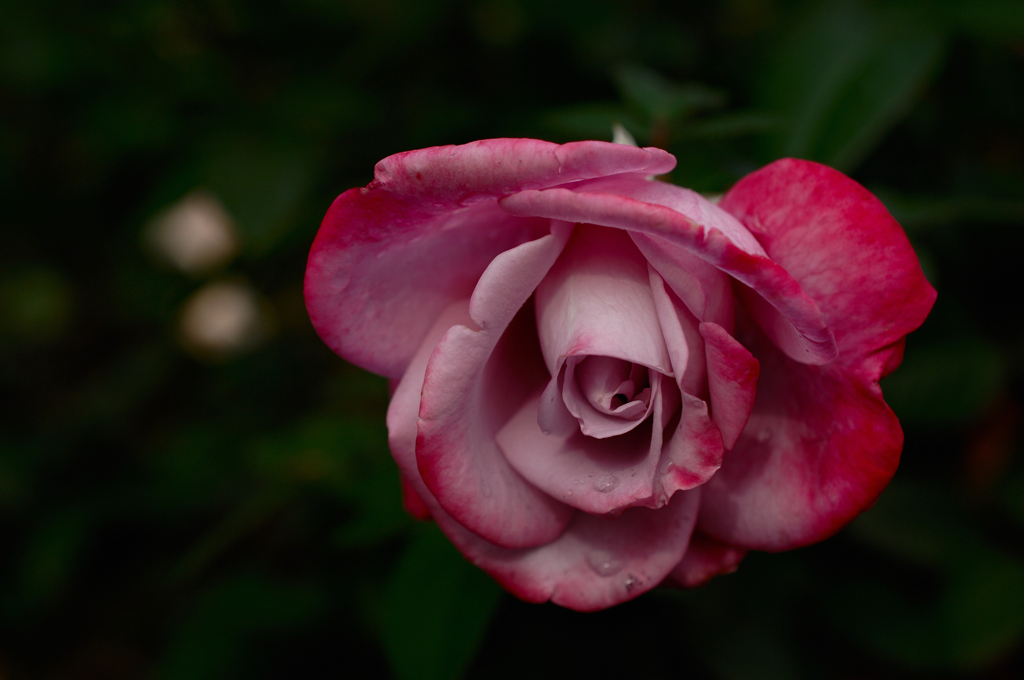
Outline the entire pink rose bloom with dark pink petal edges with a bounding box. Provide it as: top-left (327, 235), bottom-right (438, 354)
top-left (305, 139), bottom-right (935, 610)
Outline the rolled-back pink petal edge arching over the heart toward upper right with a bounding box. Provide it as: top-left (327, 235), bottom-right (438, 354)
top-left (500, 183), bottom-right (837, 365)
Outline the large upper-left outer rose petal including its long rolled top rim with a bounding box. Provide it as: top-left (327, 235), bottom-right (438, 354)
top-left (305, 139), bottom-right (675, 378)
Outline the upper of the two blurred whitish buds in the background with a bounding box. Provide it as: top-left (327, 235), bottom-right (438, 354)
top-left (146, 189), bottom-right (239, 277)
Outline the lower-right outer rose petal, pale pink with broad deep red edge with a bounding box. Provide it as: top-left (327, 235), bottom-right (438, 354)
top-left (700, 321), bottom-right (903, 550)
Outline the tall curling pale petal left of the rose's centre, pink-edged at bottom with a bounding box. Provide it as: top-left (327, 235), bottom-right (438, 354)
top-left (416, 228), bottom-right (571, 548)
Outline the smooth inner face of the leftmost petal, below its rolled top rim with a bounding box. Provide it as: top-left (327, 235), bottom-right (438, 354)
top-left (305, 196), bottom-right (549, 378)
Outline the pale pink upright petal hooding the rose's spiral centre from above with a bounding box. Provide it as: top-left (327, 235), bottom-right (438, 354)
top-left (536, 225), bottom-right (670, 376)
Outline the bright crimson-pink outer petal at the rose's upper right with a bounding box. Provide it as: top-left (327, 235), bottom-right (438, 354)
top-left (721, 159), bottom-right (935, 360)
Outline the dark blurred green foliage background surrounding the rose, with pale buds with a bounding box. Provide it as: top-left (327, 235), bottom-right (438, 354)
top-left (0, 0), bottom-right (1024, 680)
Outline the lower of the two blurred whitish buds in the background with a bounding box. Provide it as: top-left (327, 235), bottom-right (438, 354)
top-left (178, 282), bottom-right (271, 358)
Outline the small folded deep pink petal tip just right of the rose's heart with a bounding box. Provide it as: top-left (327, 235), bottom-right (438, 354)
top-left (699, 322), bottom-right (760, 450)
